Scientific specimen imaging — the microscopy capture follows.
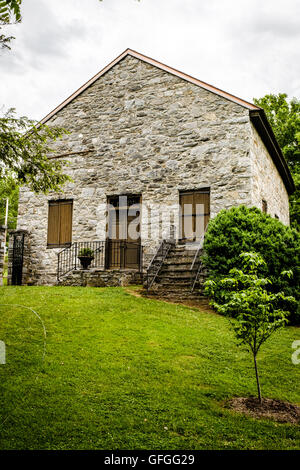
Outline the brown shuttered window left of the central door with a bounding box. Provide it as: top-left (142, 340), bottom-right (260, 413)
top-left (47, 200), bottom-right (73, 248)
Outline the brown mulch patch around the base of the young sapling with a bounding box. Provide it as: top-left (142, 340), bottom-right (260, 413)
top-left (227, 397), bottom-right (300, 424)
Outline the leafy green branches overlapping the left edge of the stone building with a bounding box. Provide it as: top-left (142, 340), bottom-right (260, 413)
top-left (0, 109), bottom-right (70, 193)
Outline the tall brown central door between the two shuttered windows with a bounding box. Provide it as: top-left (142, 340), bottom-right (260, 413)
top-left (106, 196), bottom-right (141, 269)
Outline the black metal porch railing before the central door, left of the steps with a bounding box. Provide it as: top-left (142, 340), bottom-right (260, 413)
top-left (57, 240), bottom-right (143, 280)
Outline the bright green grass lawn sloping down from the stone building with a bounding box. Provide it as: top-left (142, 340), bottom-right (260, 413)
top-left (0, 287), bottom-right (300, 450)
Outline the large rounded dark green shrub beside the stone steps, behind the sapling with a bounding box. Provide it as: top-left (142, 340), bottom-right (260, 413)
top-left (203, 206), bottom-right (300, 324)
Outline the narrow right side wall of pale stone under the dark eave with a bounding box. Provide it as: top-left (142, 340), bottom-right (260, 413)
top-left (250, 124), bottom-right (290, 225)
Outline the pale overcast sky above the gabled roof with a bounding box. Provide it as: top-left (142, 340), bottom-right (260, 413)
top-left (0, 0), bottom-right (300, 120)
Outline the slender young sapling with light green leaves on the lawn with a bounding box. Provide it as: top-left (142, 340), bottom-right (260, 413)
top-left (205, 252), bottom-right (294, 403)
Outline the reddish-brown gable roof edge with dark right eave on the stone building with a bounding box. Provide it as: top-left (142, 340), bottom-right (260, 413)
top-left (40, 48), bottom-right (295, 193)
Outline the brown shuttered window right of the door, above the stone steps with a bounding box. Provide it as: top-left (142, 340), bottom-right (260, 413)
top-left (179, 189), bottom-right (210, 241)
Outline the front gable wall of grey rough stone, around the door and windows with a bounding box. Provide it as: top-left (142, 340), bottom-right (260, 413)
top-left (18, 56), bottom-right (290, 284)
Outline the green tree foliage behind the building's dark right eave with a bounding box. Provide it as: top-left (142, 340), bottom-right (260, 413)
top-left (254, 93), bottom-right (300, 230)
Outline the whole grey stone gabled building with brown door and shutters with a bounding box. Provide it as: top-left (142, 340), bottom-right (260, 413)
top-left (11, 49), bottom-right (294, 285)
